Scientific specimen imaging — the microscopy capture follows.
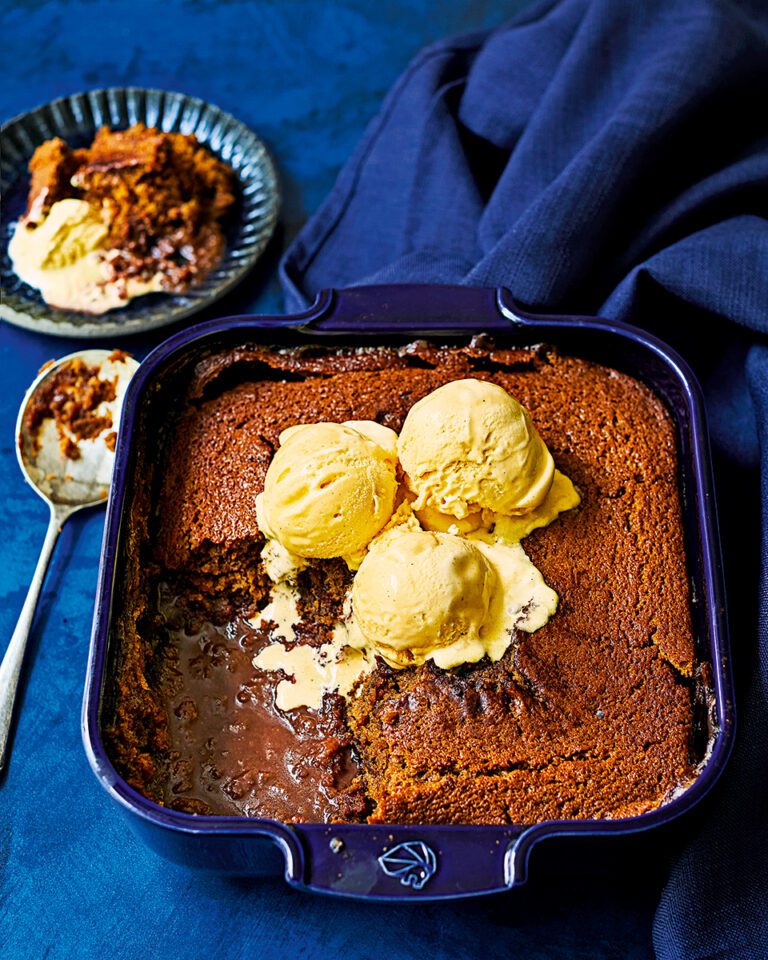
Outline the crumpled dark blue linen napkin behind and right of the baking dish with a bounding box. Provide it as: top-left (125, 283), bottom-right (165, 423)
top-left (281, 0), bottom-right (768, 960)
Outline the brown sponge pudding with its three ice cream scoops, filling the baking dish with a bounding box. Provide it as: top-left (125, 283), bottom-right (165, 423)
top-left (104, 339), bottom-right (706, 825)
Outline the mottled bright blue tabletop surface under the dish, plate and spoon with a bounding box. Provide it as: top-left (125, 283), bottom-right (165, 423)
top-left (0, 0), bottom-right (660, 960)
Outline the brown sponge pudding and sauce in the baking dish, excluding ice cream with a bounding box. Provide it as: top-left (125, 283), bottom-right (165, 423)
top-left (107, 338), bottom-right (701, 824)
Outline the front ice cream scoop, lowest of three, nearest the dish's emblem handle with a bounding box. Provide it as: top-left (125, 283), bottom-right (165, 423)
top-left (352, 530), bottom-right (497, 667)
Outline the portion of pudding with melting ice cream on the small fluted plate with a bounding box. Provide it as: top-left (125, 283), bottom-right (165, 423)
top-left (8, 123), bottom-right (235, 314)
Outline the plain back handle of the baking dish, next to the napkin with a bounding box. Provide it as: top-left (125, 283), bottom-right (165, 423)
top-left (302, 284), bottom-right (514, 337)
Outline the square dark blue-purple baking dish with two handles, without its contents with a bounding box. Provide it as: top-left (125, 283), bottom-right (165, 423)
top-left (82, 285), bottom-right (735, 901)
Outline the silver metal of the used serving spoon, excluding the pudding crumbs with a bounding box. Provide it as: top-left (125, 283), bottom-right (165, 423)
top-left (0, 350), bottom-right (138, 771)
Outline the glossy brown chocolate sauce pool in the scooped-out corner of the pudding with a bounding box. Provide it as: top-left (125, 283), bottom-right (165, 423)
top-left (158, 595), bottom-right (365, 822)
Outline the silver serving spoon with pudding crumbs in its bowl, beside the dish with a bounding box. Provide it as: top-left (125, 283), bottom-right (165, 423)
top-left (0, 350), bottom-right (138, 771)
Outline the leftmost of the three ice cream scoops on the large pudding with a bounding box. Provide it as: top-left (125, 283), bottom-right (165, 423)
top-left (256, 421), bottom-right (397, 566)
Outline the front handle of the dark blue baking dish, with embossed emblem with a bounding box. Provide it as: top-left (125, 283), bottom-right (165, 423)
top-left (287, 824), bottom-right (525, 900)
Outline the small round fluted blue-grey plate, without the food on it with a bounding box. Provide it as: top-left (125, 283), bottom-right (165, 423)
top-left (0, 87), bottom-right (280, 338)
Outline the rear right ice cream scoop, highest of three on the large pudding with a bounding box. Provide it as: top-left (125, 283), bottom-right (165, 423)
top-left (398, 379), bottom-right (555, 520)
